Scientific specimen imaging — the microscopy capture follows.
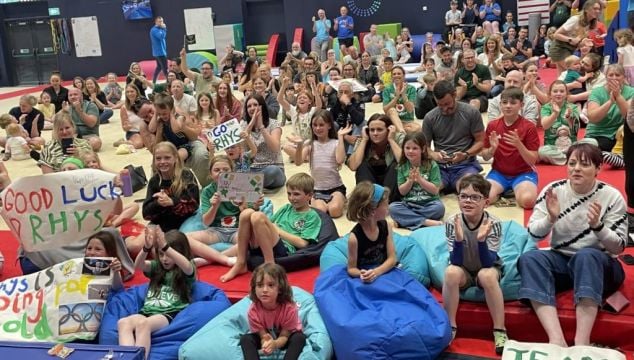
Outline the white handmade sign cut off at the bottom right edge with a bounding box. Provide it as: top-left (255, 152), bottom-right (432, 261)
top-left (502, 340), bottom-right (625, 360)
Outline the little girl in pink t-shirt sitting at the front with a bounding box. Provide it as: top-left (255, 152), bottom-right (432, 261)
top-left (240, 264), bottom-right (306, 360)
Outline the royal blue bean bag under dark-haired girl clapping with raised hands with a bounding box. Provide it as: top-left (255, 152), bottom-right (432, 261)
top-left (99, 281), bottom-right (231, 360)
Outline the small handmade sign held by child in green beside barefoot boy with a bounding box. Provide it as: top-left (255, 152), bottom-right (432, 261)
top-left (218, 173), bottom-right (264, 203)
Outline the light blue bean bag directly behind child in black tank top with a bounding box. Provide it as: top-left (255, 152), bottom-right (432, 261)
top-left (319, 233), bottom-right (431, 286)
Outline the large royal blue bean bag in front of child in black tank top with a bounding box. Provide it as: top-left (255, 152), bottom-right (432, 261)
top-left (315, 265), bottom-right (451, 360)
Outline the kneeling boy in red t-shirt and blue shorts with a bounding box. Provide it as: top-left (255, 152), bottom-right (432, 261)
top-left (480, 88), bottom-right (539, 209)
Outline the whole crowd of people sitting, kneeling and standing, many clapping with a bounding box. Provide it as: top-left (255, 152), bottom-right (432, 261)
top-left (0, 0), bottom-right (634, 356)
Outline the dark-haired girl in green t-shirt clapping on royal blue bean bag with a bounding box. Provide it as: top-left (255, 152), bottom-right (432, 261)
top-left (117, 226), bottom-right (196, 358)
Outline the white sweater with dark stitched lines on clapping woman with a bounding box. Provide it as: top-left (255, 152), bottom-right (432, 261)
top-left (528, 180), bottom-right (627, 257)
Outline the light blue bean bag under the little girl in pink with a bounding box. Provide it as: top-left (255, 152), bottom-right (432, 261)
top-left (178, 287), bottom-right (332, 360)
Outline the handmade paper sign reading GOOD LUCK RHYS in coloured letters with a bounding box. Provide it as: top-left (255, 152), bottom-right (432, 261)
top-left (0, 169), bottom-right (121, 251)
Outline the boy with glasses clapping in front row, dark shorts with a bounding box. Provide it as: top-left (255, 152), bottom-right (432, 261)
top-left (442, 174), bottom-right (508, 354)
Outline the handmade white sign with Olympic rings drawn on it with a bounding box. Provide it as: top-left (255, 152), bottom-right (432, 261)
top-left (0, 258), bottom-right (113, 342)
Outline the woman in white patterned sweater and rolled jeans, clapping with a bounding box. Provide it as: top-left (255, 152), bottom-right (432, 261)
top-left (518, 143), bottom-right (627, 347)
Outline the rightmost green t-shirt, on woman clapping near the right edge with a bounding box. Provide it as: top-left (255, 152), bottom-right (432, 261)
top-left (586, 85), bottom-right (634, 139)
